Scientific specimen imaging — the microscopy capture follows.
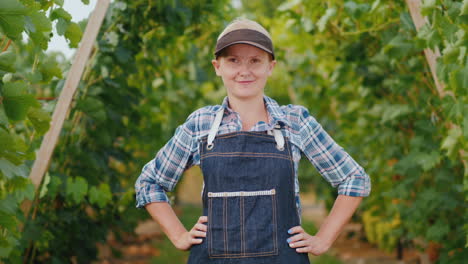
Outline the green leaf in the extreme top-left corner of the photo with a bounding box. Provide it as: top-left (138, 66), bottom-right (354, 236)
top-left (0, 0), bottom-right (27, 39)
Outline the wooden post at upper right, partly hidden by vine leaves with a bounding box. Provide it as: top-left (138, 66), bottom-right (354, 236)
top-left (406, 0), bottom-right (447, 97)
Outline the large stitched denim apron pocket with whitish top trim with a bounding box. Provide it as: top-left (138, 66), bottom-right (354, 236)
top-left (207, 189), bottom-right (278, 258)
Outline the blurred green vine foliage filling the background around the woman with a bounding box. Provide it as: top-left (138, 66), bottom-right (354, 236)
top-left (0, 0), bottom-right (468, 263)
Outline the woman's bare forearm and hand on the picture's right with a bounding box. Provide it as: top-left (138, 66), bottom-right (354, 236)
top-left (288, 195), bottom-right (362, 255)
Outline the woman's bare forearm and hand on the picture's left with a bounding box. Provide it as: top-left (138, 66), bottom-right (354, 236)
top-left (145, 202), bottom-right (208, 250)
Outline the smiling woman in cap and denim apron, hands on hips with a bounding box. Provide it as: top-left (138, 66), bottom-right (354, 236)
top-left (135, 19), bottom-right (370, 264)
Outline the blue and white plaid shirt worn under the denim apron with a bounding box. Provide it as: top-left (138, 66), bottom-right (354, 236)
top-left (135, 96), bottom-right (371, 211)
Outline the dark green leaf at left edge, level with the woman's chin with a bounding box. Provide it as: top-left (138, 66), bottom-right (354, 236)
top-left (3, 82), bottom-right (40, 121)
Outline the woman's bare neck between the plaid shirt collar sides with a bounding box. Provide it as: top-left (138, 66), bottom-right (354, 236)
top-left (229, 96), bottom-right (268, 131)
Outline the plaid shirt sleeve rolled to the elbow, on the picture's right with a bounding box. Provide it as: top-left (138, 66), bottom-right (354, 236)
top-left (300, 108), bottom-right (371, 196)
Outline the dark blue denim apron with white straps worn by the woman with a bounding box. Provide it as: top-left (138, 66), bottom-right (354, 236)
top-left (188, 109), bottom-right (309, 264)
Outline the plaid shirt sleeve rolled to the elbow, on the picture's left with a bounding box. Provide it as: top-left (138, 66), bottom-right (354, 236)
top-left (135, 123), bottom-right (196, 208)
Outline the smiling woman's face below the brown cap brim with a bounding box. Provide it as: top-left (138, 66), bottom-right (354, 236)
top-left (212, 44), bottom-right (276, 100)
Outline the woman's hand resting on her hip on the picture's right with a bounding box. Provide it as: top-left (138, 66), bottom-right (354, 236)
top-left (288, 226), bottom-right (331, 256)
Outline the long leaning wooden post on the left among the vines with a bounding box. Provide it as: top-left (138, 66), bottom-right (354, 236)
top-left (29, 0), bottom-right (110, 190)
